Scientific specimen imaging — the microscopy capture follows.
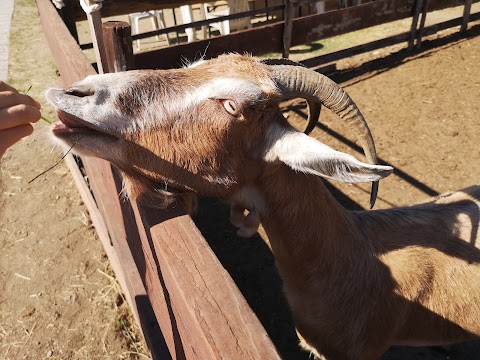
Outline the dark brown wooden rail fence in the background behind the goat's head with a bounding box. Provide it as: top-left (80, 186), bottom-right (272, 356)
top-left (59, 0), bottom-right (479, 69)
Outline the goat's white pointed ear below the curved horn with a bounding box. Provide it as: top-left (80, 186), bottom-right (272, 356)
top-left (266, 131), bottom-right (393, 183)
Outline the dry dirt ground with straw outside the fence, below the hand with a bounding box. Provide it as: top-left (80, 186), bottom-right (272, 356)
top-left (0, 0), bottom-right (148, 360)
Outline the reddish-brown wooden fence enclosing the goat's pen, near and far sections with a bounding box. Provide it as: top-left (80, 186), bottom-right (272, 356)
top-left (37, 0), bottom-right (477, 360)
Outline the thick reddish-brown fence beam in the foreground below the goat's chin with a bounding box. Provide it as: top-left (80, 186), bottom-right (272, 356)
top-left (132, 203), bottom-right (279, 360)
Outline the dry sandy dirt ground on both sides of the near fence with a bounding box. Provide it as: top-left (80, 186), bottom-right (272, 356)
top-left (0, 0), bottom-right (480, 360)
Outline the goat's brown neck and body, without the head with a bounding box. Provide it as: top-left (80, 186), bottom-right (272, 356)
top-left (259, 165), bottom-right (480, 359)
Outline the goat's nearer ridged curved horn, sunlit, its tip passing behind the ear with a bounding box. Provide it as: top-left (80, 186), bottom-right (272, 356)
top-left (270, 64), bottom-right (378, 208)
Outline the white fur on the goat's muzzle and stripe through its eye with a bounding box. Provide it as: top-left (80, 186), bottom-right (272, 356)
top-left (45, 72), bottom-right (262, 134)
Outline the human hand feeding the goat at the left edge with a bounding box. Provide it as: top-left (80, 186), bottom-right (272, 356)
top-left (0, 81), bottom-right (41, 157)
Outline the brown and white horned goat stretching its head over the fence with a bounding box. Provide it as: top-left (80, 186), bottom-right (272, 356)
top-left (46, 54), bottom-right (480, 360)
